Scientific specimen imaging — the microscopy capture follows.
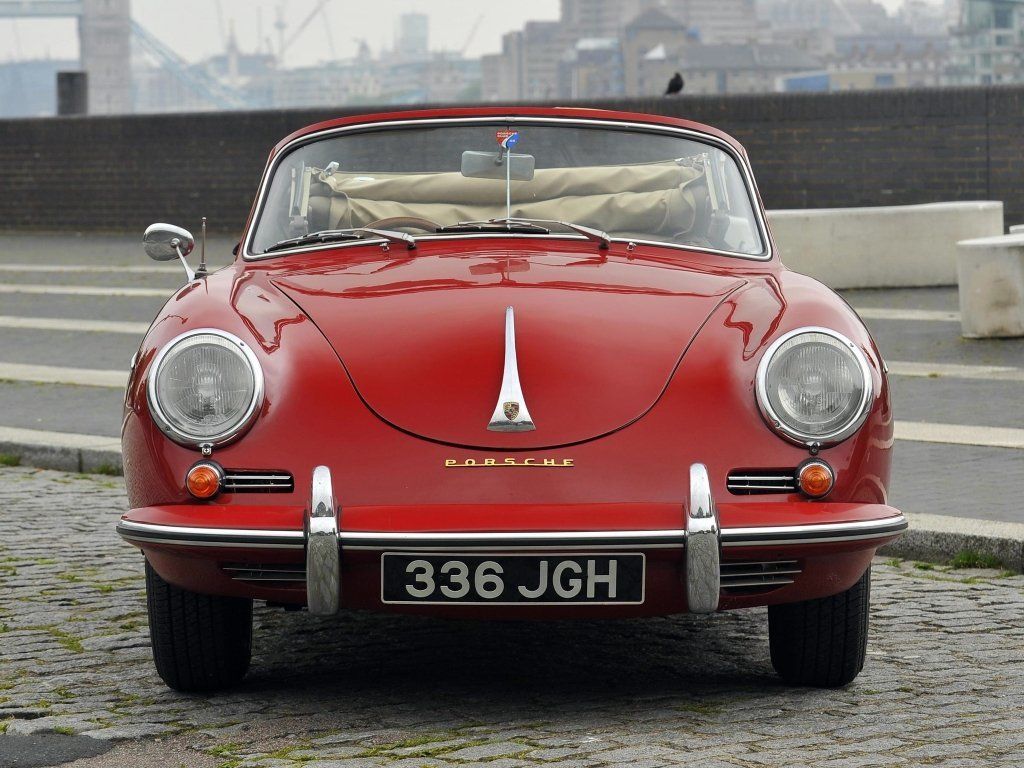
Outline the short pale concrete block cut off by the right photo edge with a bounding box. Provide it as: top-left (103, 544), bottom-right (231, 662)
top-left (956, 233), bottom-right (1024, 339)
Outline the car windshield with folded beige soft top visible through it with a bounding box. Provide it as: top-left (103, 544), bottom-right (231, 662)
top-left (245, 121), bottom-right (765, 256)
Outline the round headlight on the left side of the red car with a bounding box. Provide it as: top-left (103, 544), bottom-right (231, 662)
top-left (147, 329), bottom-right (263, 446)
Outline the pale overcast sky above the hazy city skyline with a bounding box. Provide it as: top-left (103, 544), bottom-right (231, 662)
top-left (0, 0), bottom-right (558, 67)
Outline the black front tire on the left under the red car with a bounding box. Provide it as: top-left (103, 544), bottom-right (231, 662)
top-left (145, 560), bottom-right (253, 691)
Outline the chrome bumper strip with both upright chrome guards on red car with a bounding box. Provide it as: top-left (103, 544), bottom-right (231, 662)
top-left (118, 464), bottom-right (907, 615)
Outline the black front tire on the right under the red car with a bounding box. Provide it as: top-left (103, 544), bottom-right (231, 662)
top-left (768, 568), bottom-right (871, 688)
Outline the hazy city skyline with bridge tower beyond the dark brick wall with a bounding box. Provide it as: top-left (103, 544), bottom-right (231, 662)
top-left (0, 0), bottom-right (1024, 116)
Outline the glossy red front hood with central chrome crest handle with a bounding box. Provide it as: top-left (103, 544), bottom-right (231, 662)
top-left (273, 250), bottom-right (743, 450)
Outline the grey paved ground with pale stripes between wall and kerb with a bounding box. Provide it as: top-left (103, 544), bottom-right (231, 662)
top-left (0, 234), bottom-right (1024, 521)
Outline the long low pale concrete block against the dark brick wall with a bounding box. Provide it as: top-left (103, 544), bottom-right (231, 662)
top-left (768, 201), bottom-right (1004, 289)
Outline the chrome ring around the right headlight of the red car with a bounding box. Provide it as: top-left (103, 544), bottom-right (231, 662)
top-left (755, 326), bottom-right (874, 446)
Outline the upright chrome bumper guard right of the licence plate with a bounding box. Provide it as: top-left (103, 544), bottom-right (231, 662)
top-left (686, 464), bottom-right (722, 613)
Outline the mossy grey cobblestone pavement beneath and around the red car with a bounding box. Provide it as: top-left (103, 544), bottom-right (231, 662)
top-left (0, 468), bottom-right (1024, 768)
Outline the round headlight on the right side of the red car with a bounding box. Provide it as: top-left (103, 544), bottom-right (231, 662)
top-left (757, 328), bottom-right (871, 445)
